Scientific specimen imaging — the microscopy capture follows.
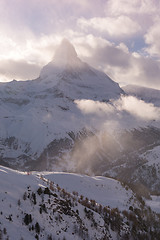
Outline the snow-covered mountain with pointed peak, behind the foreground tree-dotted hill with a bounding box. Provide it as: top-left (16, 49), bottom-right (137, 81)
top-left (0, 40), bottom-right (160, 195)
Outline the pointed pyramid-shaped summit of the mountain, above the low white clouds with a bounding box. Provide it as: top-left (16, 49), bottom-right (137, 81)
top-left (40, 39), bottom-right (123, 101)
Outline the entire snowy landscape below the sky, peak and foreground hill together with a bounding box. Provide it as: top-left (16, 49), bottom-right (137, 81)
top-left (0, 40), bottom-right (160, 240)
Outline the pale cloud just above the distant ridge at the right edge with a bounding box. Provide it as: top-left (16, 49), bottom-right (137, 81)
top-left (105, 53), bottom-right (160, 89)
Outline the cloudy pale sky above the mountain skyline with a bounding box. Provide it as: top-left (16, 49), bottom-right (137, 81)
top-left (0, 0), bottom-right (160, 89)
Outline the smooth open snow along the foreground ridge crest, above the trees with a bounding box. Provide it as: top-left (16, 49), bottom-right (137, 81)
top-left (0, 166), bottom-right (138, 213)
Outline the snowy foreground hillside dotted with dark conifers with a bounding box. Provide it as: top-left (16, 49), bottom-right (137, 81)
top-left (0, 166), bottom-right (160, 240)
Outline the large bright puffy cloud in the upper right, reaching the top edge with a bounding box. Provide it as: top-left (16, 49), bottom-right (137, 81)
top-left (77, 0), bottom-right (160, 39)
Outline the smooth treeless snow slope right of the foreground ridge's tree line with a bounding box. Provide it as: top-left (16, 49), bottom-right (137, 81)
top-left (44, 173), bottom-right (138, 210)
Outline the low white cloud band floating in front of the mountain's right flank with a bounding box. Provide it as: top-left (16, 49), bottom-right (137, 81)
top-left (75, 96), bottom-right (160, 123)
